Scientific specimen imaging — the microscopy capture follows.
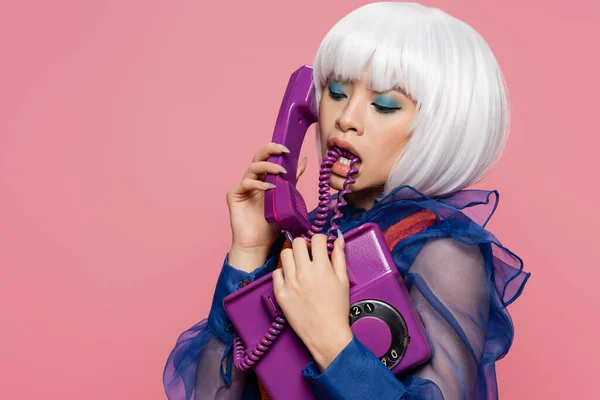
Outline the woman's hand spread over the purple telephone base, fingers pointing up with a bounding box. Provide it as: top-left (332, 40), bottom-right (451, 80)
top-left (273, 231), bottom-right (352, 372)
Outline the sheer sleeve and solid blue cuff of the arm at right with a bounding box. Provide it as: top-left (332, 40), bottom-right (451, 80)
top-left (304, 238), bottom-right (495, 400)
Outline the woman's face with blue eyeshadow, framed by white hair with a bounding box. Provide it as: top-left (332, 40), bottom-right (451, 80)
top-left (319, 71), bottom-right (416, 208)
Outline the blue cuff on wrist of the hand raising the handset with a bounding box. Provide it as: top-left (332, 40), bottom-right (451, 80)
top-left (208, 247), bottom-right (279, 344)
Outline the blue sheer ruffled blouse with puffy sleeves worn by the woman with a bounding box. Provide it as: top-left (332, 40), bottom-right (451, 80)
top-left (163, 186), bottom-right (530, 400)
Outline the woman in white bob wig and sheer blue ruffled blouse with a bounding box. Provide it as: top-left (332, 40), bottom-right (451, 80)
top-left (164, 3), bottom-right (529, 399)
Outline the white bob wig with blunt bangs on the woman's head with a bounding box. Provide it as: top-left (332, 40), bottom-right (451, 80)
top-left (313, 2), bottom-right (509, 197)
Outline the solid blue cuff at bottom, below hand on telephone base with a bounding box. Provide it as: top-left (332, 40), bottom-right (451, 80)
top-left (302, 336), bottom-right (406, 400)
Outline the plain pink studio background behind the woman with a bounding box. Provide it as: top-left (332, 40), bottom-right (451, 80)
top-left (0, 0), bottom-right (600, 399)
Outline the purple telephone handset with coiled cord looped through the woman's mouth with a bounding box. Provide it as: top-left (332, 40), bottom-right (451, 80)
top-left (265, 65), bottom-right (360, 252)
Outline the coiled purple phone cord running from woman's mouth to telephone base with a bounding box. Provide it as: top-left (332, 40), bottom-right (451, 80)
top-left (233, 147), bottom-right (360, 371)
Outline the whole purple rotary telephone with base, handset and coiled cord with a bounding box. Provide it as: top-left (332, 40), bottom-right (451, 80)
top-left (224, 66), bottom-right (431, 400)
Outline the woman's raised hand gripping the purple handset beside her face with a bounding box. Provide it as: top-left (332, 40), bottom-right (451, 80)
top-left (227, 143), bottom-right (306, 272)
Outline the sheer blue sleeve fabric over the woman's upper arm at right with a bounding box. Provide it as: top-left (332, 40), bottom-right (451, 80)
top-left (403, 238), bottom-right (495, 399)
